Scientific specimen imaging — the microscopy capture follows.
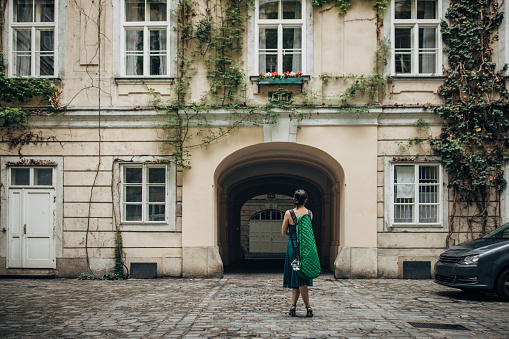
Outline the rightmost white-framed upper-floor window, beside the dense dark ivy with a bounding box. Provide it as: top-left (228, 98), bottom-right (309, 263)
top-left (391, 0), bottom-right (442, 75)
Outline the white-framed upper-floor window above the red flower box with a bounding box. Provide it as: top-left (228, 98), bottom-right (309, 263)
top-left (255, 0), bottom-right (306, 74)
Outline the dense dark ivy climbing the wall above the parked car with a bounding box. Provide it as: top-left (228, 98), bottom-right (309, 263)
top-left (431, 0), bottom-right (509, 246)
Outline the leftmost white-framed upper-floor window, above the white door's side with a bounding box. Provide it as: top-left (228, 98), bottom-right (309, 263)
top-left (10, 0), bottom-right (57, 77)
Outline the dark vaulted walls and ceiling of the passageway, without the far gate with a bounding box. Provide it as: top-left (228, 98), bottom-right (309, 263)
top-left (212, 143), bottom-right (343, 274)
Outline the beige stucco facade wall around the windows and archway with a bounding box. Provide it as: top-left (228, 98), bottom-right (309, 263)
top-left (0, 0), bottom-right (472, 277)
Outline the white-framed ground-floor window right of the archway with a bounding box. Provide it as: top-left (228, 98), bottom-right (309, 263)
top-left (390, 163), bottom-right (443, 226)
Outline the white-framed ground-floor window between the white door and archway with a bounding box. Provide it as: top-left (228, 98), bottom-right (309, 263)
top-left (121, 164), bottom-right (169, 223)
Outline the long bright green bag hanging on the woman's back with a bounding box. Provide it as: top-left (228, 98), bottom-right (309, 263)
top-left (291, 211), bottom-right (322, 279)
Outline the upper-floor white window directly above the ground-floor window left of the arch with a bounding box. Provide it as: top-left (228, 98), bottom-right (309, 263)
top-left (122, 0), bottom-right (170, 77)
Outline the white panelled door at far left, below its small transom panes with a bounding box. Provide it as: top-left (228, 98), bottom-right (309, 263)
top-left (9, 189), bottom-right (56, 268)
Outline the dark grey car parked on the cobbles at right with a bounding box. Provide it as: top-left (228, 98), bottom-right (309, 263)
top-left (435, 223), bottom-right (509, 301)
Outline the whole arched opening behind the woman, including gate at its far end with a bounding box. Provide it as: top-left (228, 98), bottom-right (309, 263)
top-left (216, 143), bottom-right (342, 272)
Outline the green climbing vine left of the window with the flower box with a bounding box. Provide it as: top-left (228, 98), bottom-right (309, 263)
top-left (157, 0), bottom-right (277, 168)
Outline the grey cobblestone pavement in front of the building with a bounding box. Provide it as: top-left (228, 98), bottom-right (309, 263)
top-left (0, 273), bottom-right (509, 338)
